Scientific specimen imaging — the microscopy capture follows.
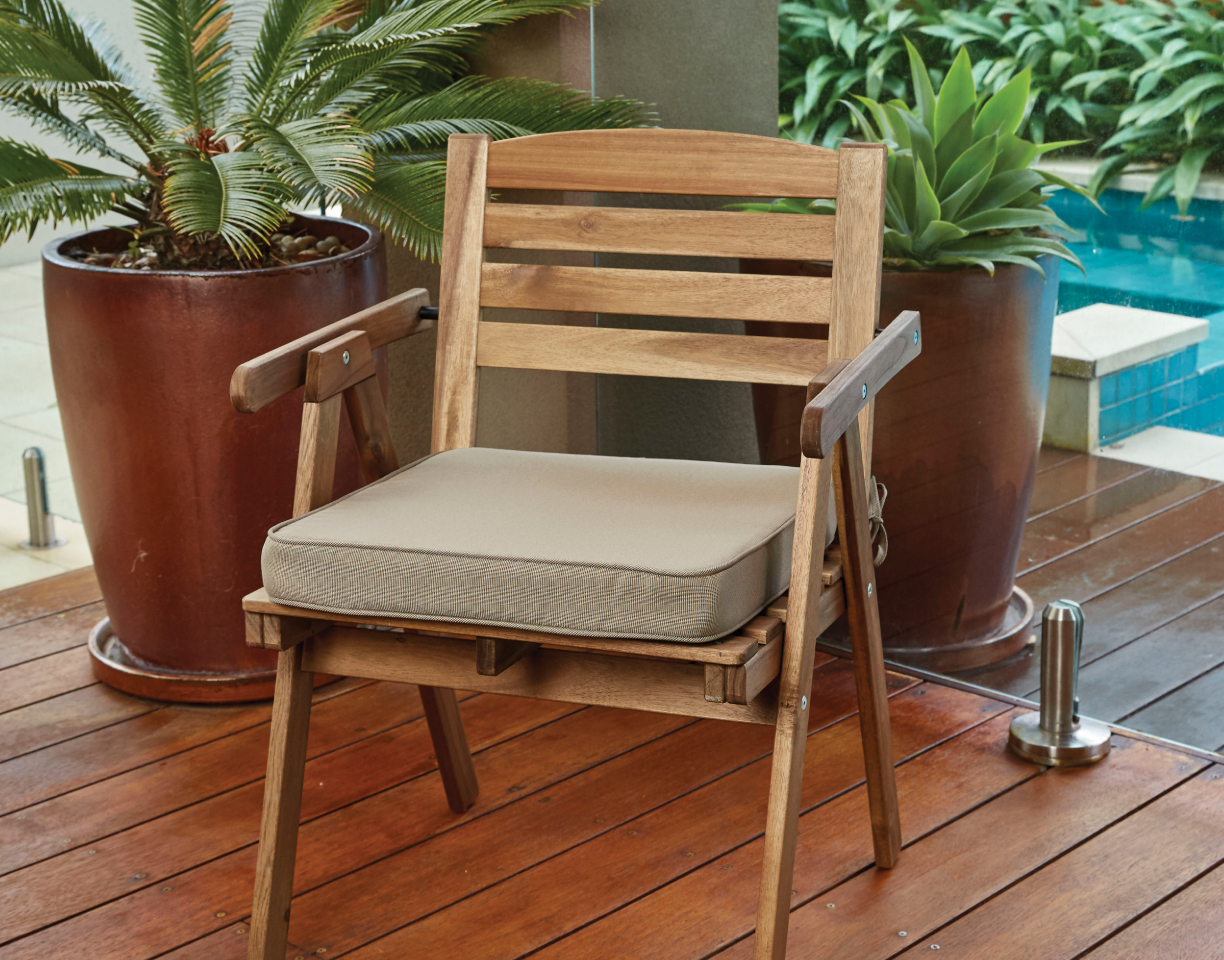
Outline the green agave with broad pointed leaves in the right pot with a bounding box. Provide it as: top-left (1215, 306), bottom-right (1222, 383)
top-left (736, 43), bottom-right (1087, 276)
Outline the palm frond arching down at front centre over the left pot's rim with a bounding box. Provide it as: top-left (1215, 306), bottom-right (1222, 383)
top-left (160, 143), bottom-right (289, 257)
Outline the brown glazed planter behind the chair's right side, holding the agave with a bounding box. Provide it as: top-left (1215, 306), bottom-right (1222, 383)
top-left (744, 257), bottom-right (1059, 671)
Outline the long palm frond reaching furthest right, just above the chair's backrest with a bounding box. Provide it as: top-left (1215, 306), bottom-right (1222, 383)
top-left (359, 77), bottom-right (654, 153)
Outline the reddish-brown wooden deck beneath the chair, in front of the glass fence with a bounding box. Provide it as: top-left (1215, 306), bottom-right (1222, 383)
top-left (0, 555), bottom-right (1224, 960)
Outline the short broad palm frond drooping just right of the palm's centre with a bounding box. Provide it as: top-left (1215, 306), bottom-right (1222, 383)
top-left (246, 116), bottom-right (373, 201)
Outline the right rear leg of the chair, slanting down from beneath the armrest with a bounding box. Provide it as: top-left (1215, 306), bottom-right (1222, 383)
top-left (835, 422), bottom-right (901, 867)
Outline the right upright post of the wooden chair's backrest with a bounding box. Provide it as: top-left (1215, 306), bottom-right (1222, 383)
top-left (829, 143), bottom-right (887, 479)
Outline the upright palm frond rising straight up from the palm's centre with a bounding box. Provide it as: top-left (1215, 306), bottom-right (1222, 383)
top-left (133, 0), bottom-right (234, 133)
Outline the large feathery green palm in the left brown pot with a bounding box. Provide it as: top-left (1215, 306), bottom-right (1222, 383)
top-left (0, 0), bottom-right (647, 266)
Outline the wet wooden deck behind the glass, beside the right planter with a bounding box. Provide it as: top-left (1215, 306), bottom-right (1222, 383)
top-left (961, 448), bottom-right (1224, 751)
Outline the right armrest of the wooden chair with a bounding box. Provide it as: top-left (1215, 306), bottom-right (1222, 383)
top-left (800, 310), bottom-right (922, 459)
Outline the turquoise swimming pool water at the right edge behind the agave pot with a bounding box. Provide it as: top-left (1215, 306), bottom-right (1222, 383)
top-left (1050, 184), bottom-right (1224, 444)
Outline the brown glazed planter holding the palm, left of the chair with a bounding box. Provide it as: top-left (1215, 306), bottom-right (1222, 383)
top-left (43, 218), bottom-right (387, 703)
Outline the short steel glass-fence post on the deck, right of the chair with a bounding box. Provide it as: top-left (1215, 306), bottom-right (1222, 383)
top-left (1007, 600), bottom-right (1110, 767)
